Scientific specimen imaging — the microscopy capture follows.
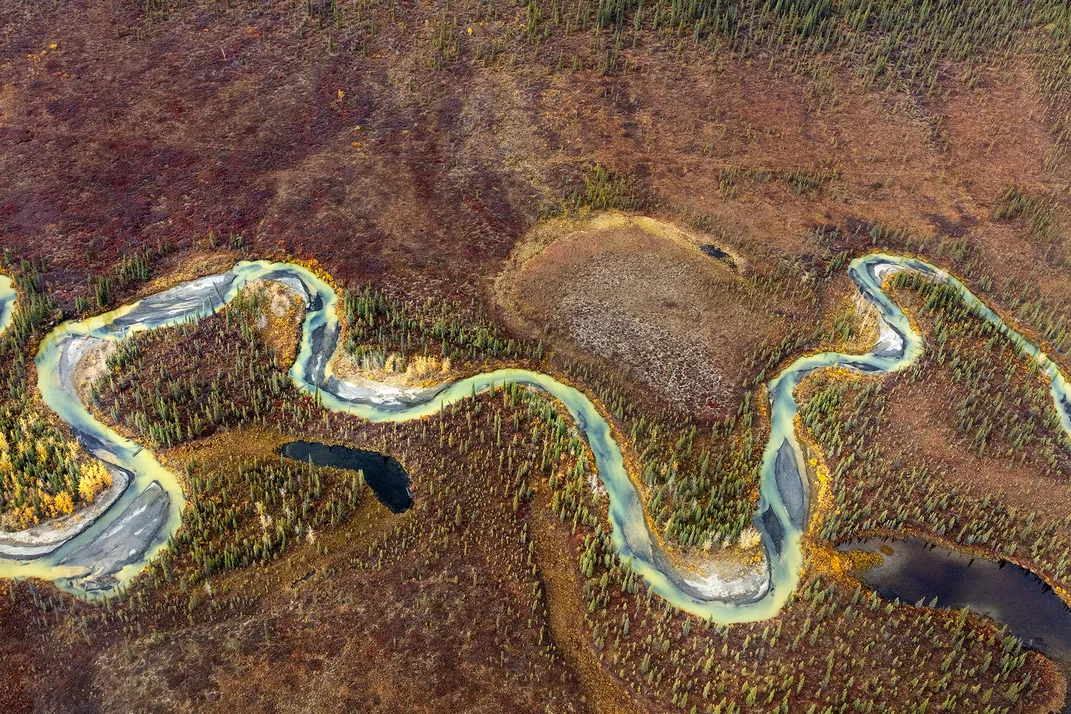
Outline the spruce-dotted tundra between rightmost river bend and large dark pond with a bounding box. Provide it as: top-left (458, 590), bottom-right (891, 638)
top-left (800, 273), bottom-right (1071, 587)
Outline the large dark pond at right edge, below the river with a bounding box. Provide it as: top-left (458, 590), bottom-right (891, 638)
top-left (841, 538), bottom-right (1071, 712)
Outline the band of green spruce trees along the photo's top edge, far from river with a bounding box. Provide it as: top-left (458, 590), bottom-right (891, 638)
top-left (162, 0), bottom-right (1071, 143)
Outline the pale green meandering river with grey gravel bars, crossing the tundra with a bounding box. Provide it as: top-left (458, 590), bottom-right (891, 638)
top-left (0, 254), bottom-right (1071, 623)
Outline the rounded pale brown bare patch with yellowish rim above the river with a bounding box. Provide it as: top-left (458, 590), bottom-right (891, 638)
top-left (498, 215), bottom-right (779, 412)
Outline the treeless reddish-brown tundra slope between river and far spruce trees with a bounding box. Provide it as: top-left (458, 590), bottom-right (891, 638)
top-left (0, 0), bottom-right (1071, 329)
